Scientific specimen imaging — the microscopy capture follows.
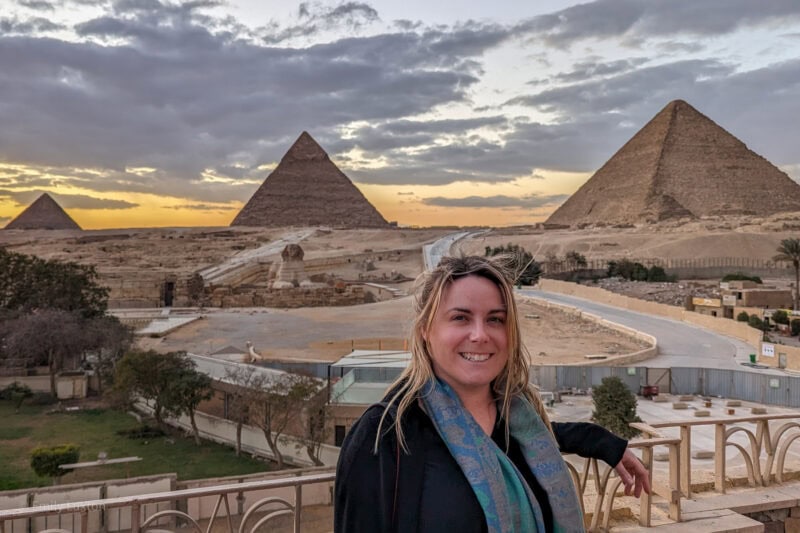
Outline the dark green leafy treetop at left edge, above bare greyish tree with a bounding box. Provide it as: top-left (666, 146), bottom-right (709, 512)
top-left (0, 248), bottom-right (108, 318)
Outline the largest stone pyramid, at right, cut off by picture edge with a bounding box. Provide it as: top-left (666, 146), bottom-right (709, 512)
top-left (545, 100), bottom-right (800, 226)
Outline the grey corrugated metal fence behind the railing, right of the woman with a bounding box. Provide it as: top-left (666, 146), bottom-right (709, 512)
top-left (531, 366), bottom-right (800, 407)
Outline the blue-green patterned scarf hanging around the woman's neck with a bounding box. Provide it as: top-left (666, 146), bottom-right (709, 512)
top-left (422, 379), bottom-right (584, 533)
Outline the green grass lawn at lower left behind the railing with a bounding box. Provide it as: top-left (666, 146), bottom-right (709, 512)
top-left (0, 400), bottom-right (273, 490)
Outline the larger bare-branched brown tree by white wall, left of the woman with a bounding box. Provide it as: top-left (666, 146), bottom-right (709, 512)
top-left (251, 373), bottom-right (321, 469)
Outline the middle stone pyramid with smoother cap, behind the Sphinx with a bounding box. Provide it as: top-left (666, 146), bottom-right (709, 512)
top-left (231, 131), bottom-right (390, 228)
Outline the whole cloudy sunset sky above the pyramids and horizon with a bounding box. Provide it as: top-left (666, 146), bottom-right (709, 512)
top-left (0, 0), bottom-right (800, 228)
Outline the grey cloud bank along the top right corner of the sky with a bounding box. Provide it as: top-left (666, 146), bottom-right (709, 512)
top-left (515, 0), bottom-right (800, 47)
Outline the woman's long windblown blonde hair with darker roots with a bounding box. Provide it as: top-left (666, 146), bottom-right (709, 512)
top-left (375, 255), bottom-right (552, 452)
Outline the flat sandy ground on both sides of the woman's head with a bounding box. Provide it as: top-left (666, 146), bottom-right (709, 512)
top-left (140, 297), bottom-right (646, 365)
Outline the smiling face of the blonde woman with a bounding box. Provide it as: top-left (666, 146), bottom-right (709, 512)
top-left (425, 276), bottom-right (508, 398)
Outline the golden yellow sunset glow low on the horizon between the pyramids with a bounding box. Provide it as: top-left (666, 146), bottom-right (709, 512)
top-left (0, 165), bottom-right (589, 229)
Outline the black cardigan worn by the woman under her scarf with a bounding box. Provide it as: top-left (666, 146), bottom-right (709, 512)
top-left (334, 403), bottom-right (627, 533)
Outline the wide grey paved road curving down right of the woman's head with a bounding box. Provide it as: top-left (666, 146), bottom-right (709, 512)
top-left (519, 289), bottom-right (782, 374)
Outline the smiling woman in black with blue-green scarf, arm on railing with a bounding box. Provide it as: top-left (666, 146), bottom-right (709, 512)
top-left (334, 257), bottom-right (649, 533)
